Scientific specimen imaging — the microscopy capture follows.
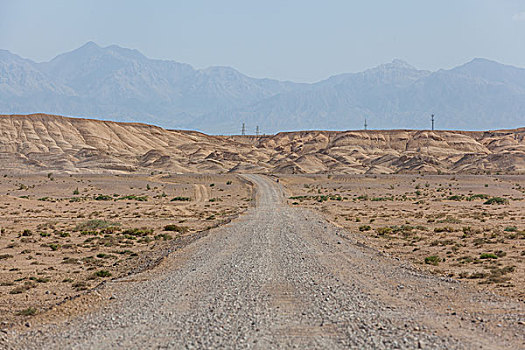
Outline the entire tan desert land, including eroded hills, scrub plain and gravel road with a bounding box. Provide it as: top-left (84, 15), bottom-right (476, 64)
top-left (0, 114), bottom-right (525, 349)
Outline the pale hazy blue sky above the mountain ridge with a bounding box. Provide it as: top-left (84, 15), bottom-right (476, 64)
top-left (0, 0), bottom-right (525, 81)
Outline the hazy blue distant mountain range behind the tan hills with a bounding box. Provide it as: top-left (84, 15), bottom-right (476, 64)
top-left (0, 42), bottom-right (525, 134)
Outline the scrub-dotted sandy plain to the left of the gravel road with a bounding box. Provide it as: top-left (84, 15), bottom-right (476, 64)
top-left (0, 173), bottom-right (252, 327)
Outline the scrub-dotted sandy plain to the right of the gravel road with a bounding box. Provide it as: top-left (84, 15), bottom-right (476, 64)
top-left (279, 175), bottom-right (525, 302)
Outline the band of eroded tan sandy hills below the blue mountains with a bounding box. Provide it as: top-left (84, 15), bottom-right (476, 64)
top-left (0, 114), bottom-right (525, 173)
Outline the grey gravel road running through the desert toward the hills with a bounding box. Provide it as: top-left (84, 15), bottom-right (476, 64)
top-left (4, 175), bottom-right (525, 349)
